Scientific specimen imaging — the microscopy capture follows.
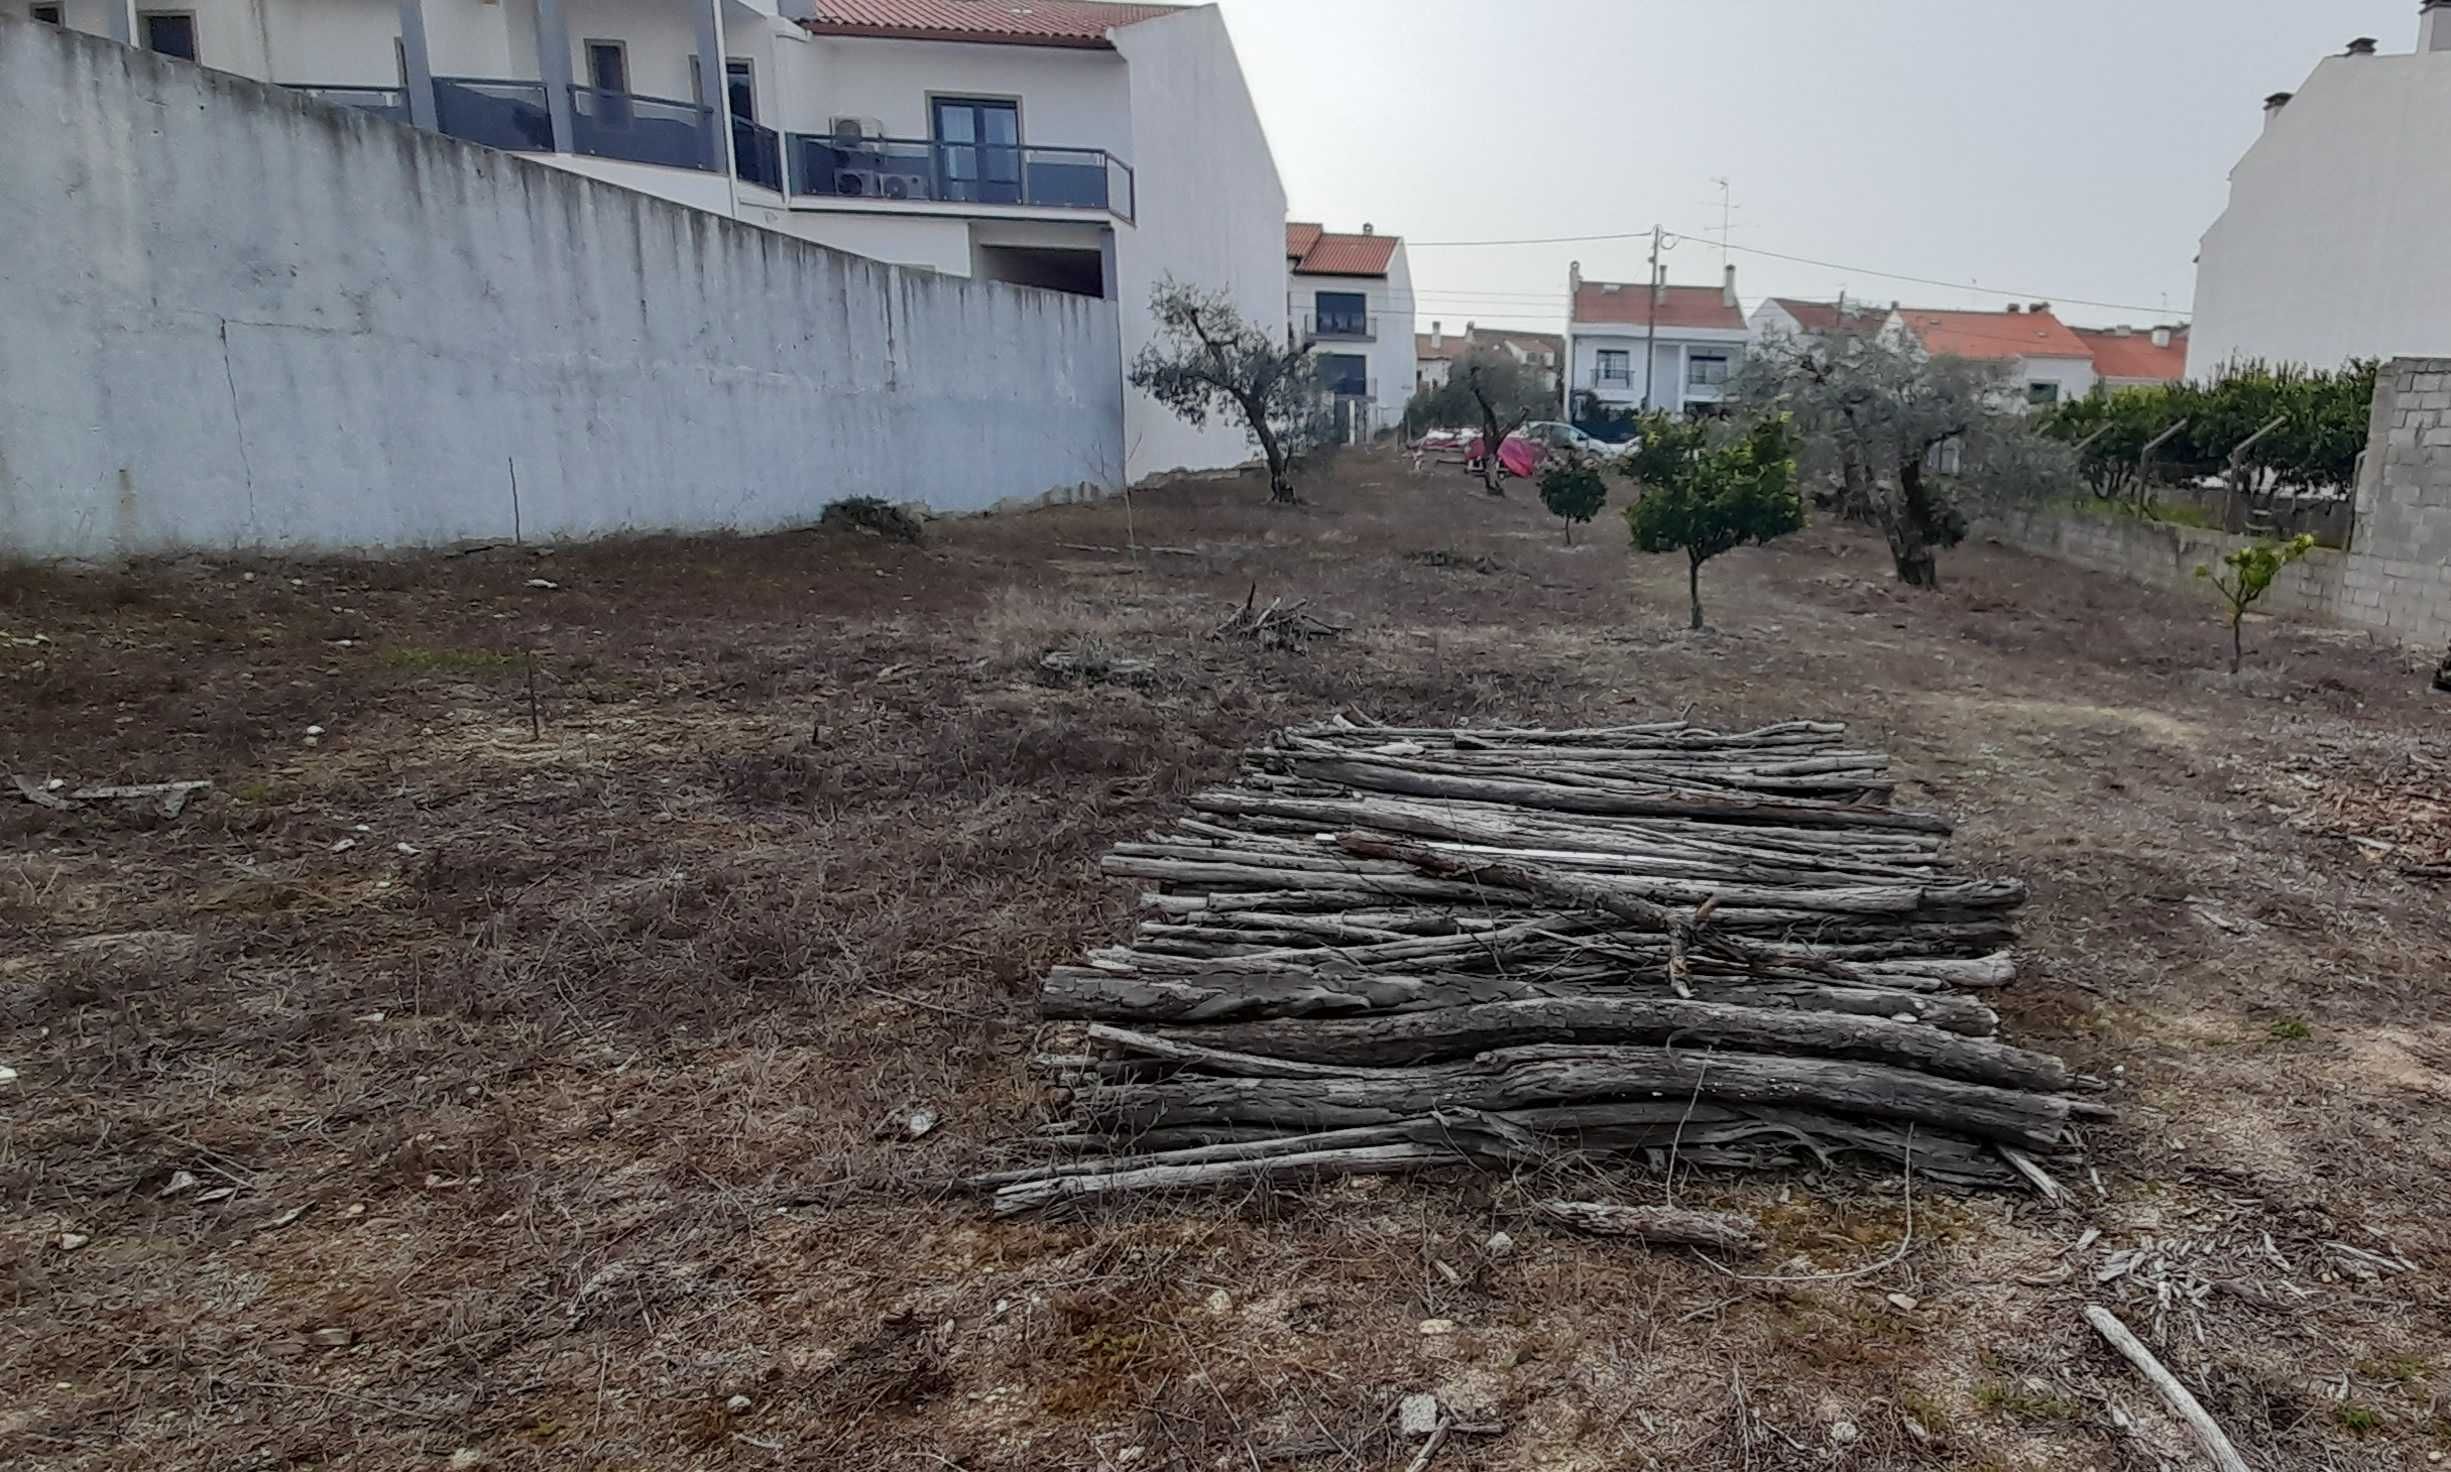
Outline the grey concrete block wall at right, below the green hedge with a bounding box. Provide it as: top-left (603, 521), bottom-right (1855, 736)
top-left (1983, 358), bottom-right (2451, 654)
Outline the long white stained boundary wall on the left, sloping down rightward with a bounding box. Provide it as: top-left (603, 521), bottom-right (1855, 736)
top-left (0, 12), bottom-right (1125, 558)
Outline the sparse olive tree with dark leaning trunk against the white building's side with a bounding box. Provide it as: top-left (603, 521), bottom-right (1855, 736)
top-left (1130, 279), bottom-right (1326, 502)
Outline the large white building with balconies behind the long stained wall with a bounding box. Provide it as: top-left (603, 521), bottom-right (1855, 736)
top-left (28, 0), bottom-right (1284, 480)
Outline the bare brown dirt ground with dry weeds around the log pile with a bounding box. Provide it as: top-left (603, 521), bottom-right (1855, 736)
top-left (14, 458), bottom-right (2451, 1472)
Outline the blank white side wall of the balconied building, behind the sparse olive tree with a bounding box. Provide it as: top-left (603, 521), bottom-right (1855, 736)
top-left (1115, 5), bottom-right (1284, 480)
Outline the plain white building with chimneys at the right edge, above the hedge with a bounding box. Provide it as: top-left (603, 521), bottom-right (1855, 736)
top-left (2186, 0), bottom-right (2451, 377)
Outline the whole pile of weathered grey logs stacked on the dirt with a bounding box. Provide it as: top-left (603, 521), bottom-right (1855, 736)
top-left (973, 718), bottom-right (2105, 1212)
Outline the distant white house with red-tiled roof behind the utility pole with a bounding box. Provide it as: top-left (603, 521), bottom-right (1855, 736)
top-left (1566, 262), bottom-right (1748, 414)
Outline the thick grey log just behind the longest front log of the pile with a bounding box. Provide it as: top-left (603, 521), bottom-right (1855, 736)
top-left (1142, 997), bottom-right (2076, 1092)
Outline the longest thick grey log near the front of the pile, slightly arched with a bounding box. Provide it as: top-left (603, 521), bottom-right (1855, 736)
top-left (1076, 1046), bottom-right (2076, 1149)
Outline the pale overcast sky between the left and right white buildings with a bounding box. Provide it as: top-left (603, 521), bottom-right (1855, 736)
top-left (1221, 0), bottom-right (2417, 331)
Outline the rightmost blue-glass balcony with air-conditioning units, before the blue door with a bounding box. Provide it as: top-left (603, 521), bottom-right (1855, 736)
top-left (784, 132), bottom-right (1132, 223)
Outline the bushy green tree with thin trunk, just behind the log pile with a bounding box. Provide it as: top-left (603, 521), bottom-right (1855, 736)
top-left (1625, 414), bottom-right (1804, 629)
